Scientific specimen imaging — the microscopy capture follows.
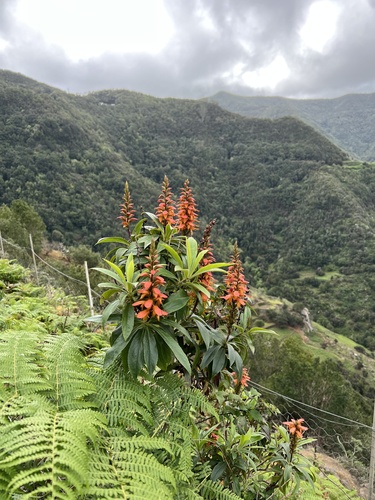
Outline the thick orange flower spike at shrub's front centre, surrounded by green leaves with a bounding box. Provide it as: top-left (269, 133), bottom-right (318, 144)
top-left (133, 243), bottom-right (168, 321)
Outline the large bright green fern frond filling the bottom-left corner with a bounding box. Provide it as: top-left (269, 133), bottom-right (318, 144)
top-left (0, 409), bottom-right (105, 499)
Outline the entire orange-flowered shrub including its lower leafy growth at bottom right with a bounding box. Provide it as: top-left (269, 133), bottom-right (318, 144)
top-left (96, 177), bottom-right (314, 499)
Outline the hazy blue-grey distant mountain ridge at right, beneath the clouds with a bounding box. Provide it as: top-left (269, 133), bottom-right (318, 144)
top-left (207, 92), bottom-right (375, 161)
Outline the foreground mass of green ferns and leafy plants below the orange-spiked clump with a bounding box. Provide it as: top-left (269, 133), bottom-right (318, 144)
top-left (0, 260), bottom-right (318, 500)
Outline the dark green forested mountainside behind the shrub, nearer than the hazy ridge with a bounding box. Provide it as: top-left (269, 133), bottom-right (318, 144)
top-left (0, 72), bottom-right (375, 350)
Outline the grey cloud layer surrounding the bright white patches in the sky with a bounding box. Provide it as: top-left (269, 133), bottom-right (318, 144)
top-left (0, 0), bottom-right (375, 97)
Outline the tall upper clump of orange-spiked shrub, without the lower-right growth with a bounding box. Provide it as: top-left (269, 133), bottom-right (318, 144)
top-left (95, 177), bottom-right (260, 380)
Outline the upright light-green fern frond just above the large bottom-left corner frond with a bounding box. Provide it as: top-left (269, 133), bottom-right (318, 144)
top-left (43, 333), bottom-right (96, 410)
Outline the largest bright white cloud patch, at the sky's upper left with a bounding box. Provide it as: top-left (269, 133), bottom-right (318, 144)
top-left (16, 0), bottom-right (174, 61)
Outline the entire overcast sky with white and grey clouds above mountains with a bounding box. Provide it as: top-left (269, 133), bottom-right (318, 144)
top-left (0, 0), bottom-right (375, 98)
